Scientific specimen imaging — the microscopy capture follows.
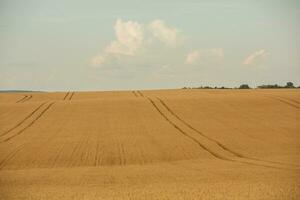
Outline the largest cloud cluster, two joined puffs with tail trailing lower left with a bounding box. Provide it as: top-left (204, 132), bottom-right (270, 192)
top-left (91, 19), bottom-right (183, 67)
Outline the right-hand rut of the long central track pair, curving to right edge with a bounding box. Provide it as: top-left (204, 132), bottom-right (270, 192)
top-left (157, 98), bottom-right (299, 167)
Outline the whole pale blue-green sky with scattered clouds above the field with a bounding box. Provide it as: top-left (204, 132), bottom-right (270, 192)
top-left (0, 0), bottom-right (300, 91)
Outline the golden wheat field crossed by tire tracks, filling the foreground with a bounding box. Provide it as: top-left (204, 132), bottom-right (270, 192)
top-left (0, 89), bottom-right (300, 200)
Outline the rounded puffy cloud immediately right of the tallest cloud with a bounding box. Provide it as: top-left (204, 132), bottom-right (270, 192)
top-left (149, 20), bottom-right (183, 47)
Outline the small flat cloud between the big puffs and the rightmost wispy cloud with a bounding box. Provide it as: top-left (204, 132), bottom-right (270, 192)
top-left (185, 48), bottom-right (224, 65)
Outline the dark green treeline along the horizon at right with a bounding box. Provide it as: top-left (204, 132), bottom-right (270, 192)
top-left (182, 82), bottom-right (300, 89)
